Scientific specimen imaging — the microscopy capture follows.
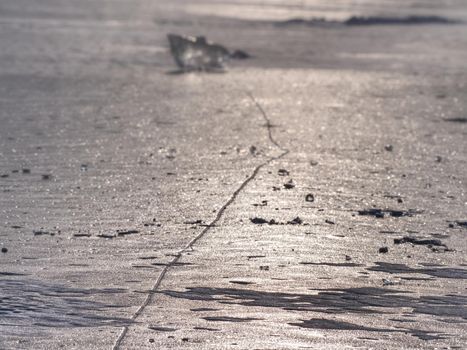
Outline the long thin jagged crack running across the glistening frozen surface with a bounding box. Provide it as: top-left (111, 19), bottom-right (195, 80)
top-left (112, 92), bottom-right (290, 350)
